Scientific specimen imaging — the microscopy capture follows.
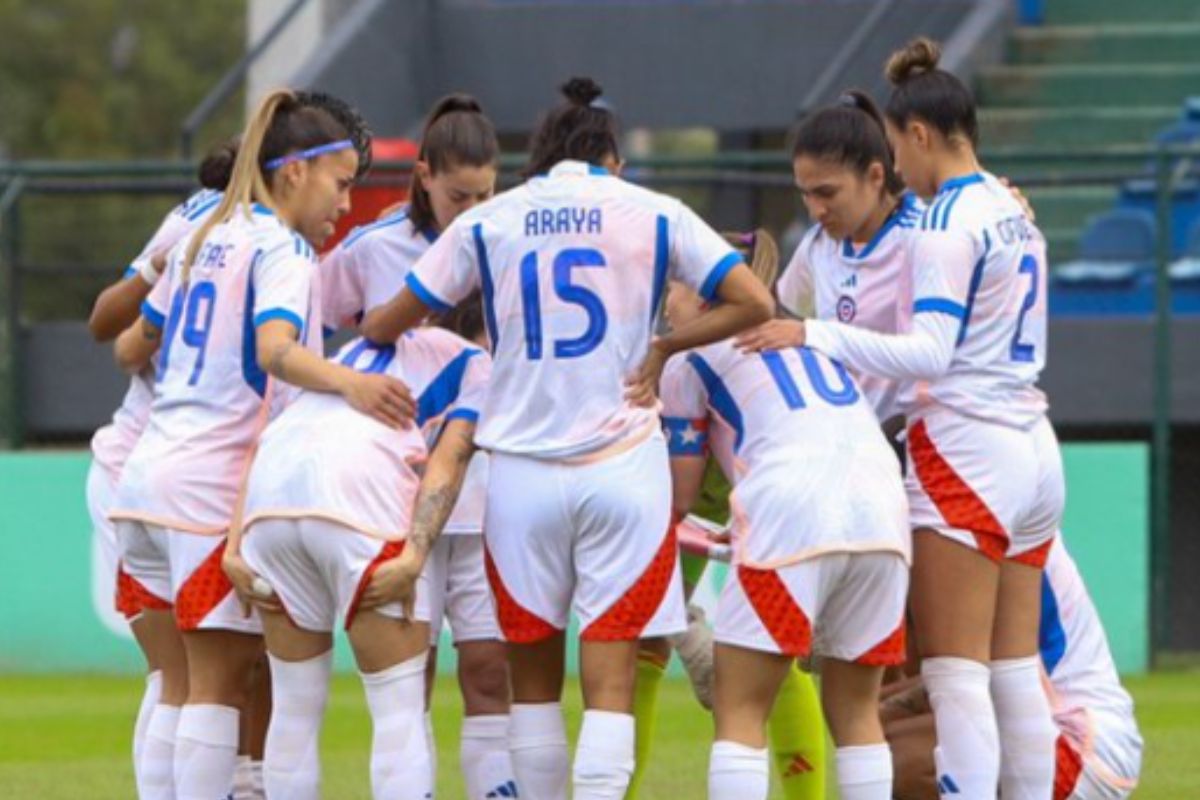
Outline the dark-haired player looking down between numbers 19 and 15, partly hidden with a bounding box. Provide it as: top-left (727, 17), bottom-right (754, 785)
top-left (322, 95), bottom-right (512, 800)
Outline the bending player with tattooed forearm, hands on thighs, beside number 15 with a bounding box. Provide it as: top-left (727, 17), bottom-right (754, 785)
top-left (229, 327), bottom-right (490, 800)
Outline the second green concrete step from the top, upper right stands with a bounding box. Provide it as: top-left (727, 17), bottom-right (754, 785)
top-left (1009, 23), bottom-right (1200, 65)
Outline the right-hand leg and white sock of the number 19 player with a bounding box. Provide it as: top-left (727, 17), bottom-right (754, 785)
top-left (175, 630), bottom-right (263, 798)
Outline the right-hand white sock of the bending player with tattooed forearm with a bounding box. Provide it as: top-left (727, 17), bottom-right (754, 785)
top-left (361, 652), bottom-right (433, 800)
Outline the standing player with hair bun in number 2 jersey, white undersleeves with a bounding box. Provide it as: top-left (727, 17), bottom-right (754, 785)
top-left (758, 40), bottom-right (1063, 798)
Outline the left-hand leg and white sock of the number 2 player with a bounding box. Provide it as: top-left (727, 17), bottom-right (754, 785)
top-left (910, 529), bottom-right (1000, 796)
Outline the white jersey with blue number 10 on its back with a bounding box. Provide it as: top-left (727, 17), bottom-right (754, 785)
top-left (662, 341), bottom-right (910, 565)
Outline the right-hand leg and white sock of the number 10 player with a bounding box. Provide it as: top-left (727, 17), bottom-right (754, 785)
top-left (821, 658), bottom-right (892, 800)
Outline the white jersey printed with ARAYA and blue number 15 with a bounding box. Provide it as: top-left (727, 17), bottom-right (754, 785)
top-left (408, 161), bottom-right (742, 459)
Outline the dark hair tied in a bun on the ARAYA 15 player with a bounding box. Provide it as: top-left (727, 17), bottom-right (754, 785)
top-left (524, 78), bottom-right (620, 178)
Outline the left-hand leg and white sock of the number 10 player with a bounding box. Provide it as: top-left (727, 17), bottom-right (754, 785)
top-left (708, 644), bottom-right (792, 800)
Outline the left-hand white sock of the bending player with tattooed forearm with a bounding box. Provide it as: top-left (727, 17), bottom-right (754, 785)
top-left (263, 650), bottom-right (334, 800)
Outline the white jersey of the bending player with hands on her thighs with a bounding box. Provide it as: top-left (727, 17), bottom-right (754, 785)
top-left (246, 327), bottom-right (491, 541)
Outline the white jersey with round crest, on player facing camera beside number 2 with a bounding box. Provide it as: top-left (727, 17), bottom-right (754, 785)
top-left (775, 192), bottom-right (925, 421)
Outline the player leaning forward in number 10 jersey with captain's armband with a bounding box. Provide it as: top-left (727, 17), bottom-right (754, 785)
top-left (662, 237), bottom-right (910, 800)
